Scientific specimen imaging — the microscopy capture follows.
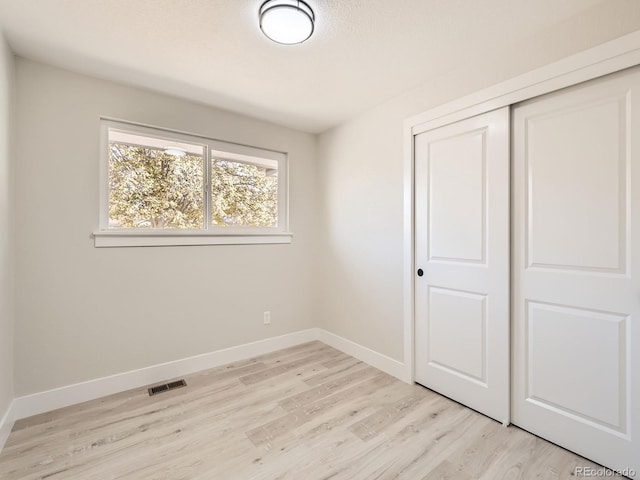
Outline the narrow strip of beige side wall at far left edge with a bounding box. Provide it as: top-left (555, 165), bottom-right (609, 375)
top-left (0, 31), bottom-right (14, 419)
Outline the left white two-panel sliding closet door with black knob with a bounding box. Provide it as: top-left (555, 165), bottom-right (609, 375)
top-left (414, 108), bottom-right (510, 423)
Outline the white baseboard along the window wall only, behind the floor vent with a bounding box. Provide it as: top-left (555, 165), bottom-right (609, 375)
top-left (9, 328), bottom-right (318, 420)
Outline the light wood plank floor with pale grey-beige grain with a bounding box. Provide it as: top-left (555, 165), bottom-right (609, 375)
top-left (0, 342), bottom-right (624, 480)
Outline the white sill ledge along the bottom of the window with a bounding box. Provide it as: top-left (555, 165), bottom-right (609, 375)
top-left (93, 230), bottom-right (293, 248)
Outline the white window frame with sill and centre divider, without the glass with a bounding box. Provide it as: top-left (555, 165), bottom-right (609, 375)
top-left (93, 117), bottom-right (293, 247)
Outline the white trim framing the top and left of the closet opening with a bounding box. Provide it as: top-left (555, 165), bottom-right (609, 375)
top-left (401, 30), bottom-right (640, 383)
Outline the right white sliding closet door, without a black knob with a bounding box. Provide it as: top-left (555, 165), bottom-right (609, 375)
top-left (512, 69), bottom-right (640, 478)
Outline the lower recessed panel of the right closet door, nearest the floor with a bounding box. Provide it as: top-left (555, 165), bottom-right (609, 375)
top-left (526, 301), bottom-right (627, 431)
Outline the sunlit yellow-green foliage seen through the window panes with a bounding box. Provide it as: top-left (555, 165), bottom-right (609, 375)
top-left (109, 143), bottom-right (278, 229)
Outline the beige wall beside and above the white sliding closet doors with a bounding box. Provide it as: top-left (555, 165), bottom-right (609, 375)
top-left (318, 0), bottom-right (640, 361)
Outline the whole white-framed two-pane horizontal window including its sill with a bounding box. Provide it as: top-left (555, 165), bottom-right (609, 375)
top-left (94, 120), bottom-right (291, 247)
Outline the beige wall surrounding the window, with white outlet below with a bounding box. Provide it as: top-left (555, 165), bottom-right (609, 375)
top-left (15, 59), bottom-right (317, 396)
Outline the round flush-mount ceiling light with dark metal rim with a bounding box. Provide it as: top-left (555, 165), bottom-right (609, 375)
top-left (260, 0), bottom-right (316, 45)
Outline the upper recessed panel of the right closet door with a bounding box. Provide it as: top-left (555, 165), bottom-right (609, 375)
top-left (524, 92), bottom-right (627, 272)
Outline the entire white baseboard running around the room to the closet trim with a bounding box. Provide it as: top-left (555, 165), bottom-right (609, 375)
top-left (5, 328), bottom-right (411, 432)
